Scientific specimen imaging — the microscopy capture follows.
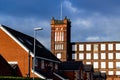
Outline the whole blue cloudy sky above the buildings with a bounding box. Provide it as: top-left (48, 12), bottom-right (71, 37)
top-left (0, 0), bottom-right (120, 49)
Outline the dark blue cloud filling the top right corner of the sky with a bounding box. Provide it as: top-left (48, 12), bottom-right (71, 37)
top-left (71, 0), bottom-right (120, 15)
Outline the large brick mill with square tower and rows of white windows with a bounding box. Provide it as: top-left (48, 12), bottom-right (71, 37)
top-left (51, 17), bottom-right (120, 79)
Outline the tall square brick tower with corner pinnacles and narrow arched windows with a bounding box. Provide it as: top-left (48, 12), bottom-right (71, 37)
top-left (51, 17), bottom-right (71, 61)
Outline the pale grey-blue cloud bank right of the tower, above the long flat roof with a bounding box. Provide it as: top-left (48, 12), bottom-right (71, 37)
top-left (72, 13), bottom-right (120, 41)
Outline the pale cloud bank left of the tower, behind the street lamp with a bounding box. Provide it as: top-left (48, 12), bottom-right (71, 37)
top-left (0, 15), bottom-right (50, 48)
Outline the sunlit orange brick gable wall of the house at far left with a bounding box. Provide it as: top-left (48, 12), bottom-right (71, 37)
top-left (0, 29), bottom-right (32, 76)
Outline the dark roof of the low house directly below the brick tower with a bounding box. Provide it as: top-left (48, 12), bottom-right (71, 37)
top-left (58, 61), bottom-right (83, 70)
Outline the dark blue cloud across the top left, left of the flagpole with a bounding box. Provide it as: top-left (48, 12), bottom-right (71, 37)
top-left (0, 0), bottom-right (59, 18)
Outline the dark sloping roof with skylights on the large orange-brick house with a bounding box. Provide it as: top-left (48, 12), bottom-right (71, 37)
top-left (1, 25), bottom-right (60, 62)
